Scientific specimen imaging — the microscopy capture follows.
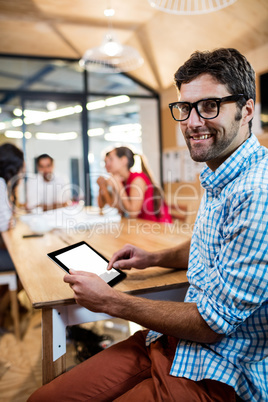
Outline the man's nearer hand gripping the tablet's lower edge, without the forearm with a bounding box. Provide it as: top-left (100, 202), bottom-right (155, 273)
top-left (63, 270), bottom-right (118, 312)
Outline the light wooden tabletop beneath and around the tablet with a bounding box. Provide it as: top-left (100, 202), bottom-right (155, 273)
top-left (3, 212), bottom-right (190, 308)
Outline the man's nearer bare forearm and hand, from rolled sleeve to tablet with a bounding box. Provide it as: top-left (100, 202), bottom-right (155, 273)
top-left (64, 266), bottom-right (222, 343)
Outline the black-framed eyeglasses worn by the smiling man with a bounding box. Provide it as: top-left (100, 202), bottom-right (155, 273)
top-left (169, 94), bottom-right (245, 121)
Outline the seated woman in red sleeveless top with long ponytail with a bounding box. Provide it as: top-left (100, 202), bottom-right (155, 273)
top-left (97, 147), bottom-right (172, 222)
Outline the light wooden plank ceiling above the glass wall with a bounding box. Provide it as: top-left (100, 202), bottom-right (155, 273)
top-left (0, 0), bottom-right (268, 92)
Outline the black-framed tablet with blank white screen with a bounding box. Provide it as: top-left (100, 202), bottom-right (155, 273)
top-left (47, 241), bottom-right (126, 286)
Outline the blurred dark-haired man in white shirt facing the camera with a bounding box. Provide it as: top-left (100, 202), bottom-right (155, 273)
top-left (26, 154), bottom-right (71, 211)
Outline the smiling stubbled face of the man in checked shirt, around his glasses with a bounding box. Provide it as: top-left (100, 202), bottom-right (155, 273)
top-left (180, 74), bottom-right (249, 170)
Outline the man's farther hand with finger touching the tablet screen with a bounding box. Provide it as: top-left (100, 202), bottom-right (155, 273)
top-left (107, 244), bottom-right (153, 270)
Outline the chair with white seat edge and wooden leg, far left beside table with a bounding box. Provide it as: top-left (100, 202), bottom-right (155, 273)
top-left (0, 270), bottom-right (20, 339)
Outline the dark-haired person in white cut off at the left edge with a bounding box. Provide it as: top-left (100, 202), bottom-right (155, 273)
top-left (0, 143), bottom-right (24, 312)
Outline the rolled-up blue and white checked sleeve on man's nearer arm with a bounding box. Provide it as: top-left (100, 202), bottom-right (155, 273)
top-left (197, 188), bottom-right (268, 335)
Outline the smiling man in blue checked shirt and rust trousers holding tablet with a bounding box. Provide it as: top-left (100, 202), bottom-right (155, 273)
top-left (30, 49), bottom-right (268, 402)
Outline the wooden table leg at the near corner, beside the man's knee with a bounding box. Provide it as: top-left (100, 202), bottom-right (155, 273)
top-left (42, 309), bottom-right (66, 384)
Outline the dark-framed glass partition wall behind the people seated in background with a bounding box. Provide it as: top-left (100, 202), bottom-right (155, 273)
top-left (0, 56), bottom-right (161, 205)
